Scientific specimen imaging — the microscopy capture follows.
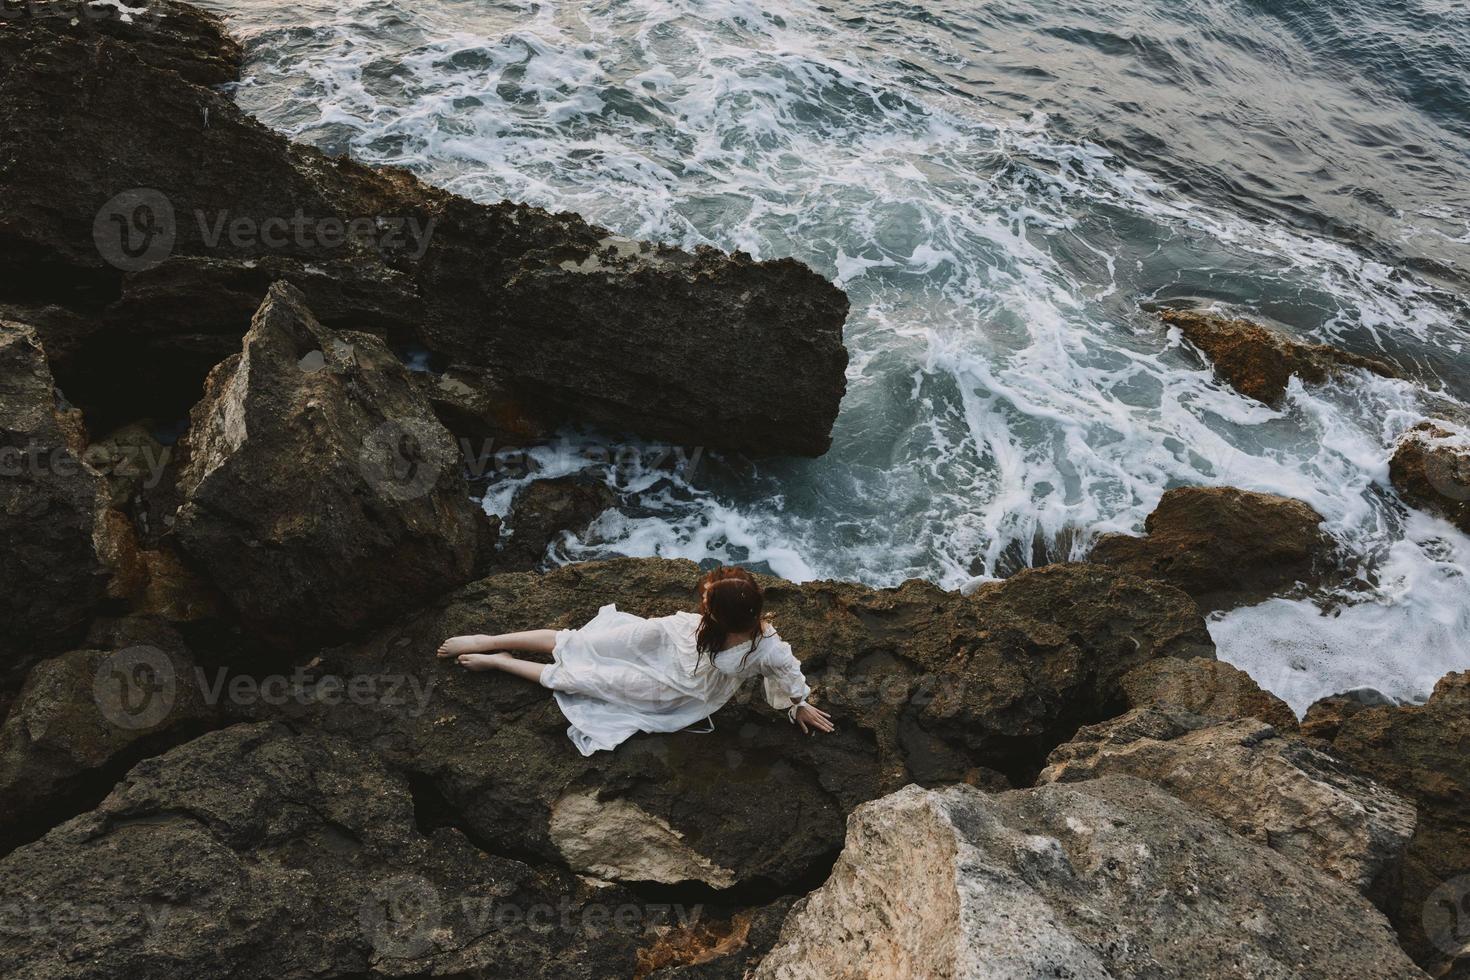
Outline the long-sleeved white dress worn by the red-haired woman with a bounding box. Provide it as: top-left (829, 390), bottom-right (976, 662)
top-left (541, 604), bottom-right (811, 755)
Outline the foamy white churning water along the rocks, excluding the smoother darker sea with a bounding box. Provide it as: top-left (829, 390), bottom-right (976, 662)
top-left (210, 0), bottom-right (1470, 708)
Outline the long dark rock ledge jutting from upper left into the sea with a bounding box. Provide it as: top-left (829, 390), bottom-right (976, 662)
top-left (0, 12), bottom-right (847, 455)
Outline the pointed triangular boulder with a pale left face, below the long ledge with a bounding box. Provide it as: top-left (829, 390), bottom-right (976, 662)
top-left (176, 284), bottom-right (484, 646)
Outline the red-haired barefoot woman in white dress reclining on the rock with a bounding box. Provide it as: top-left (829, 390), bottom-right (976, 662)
top-left (438, 569), bottom-right (833, 755)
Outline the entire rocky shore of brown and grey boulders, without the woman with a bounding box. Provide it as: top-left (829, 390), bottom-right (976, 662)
top-left (0, 0), bottom-right (1470, 980)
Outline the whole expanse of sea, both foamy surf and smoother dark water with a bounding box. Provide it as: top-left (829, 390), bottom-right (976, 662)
top-left (198, 0), bottom-right (1470, 708)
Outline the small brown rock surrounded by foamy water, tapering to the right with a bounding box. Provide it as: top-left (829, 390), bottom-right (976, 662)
top-left (1158, 310), bottom-right (1399, 406)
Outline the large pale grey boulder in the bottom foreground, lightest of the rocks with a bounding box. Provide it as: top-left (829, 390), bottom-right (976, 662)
top-left (753, 776), bottom-right (1420, 980)
